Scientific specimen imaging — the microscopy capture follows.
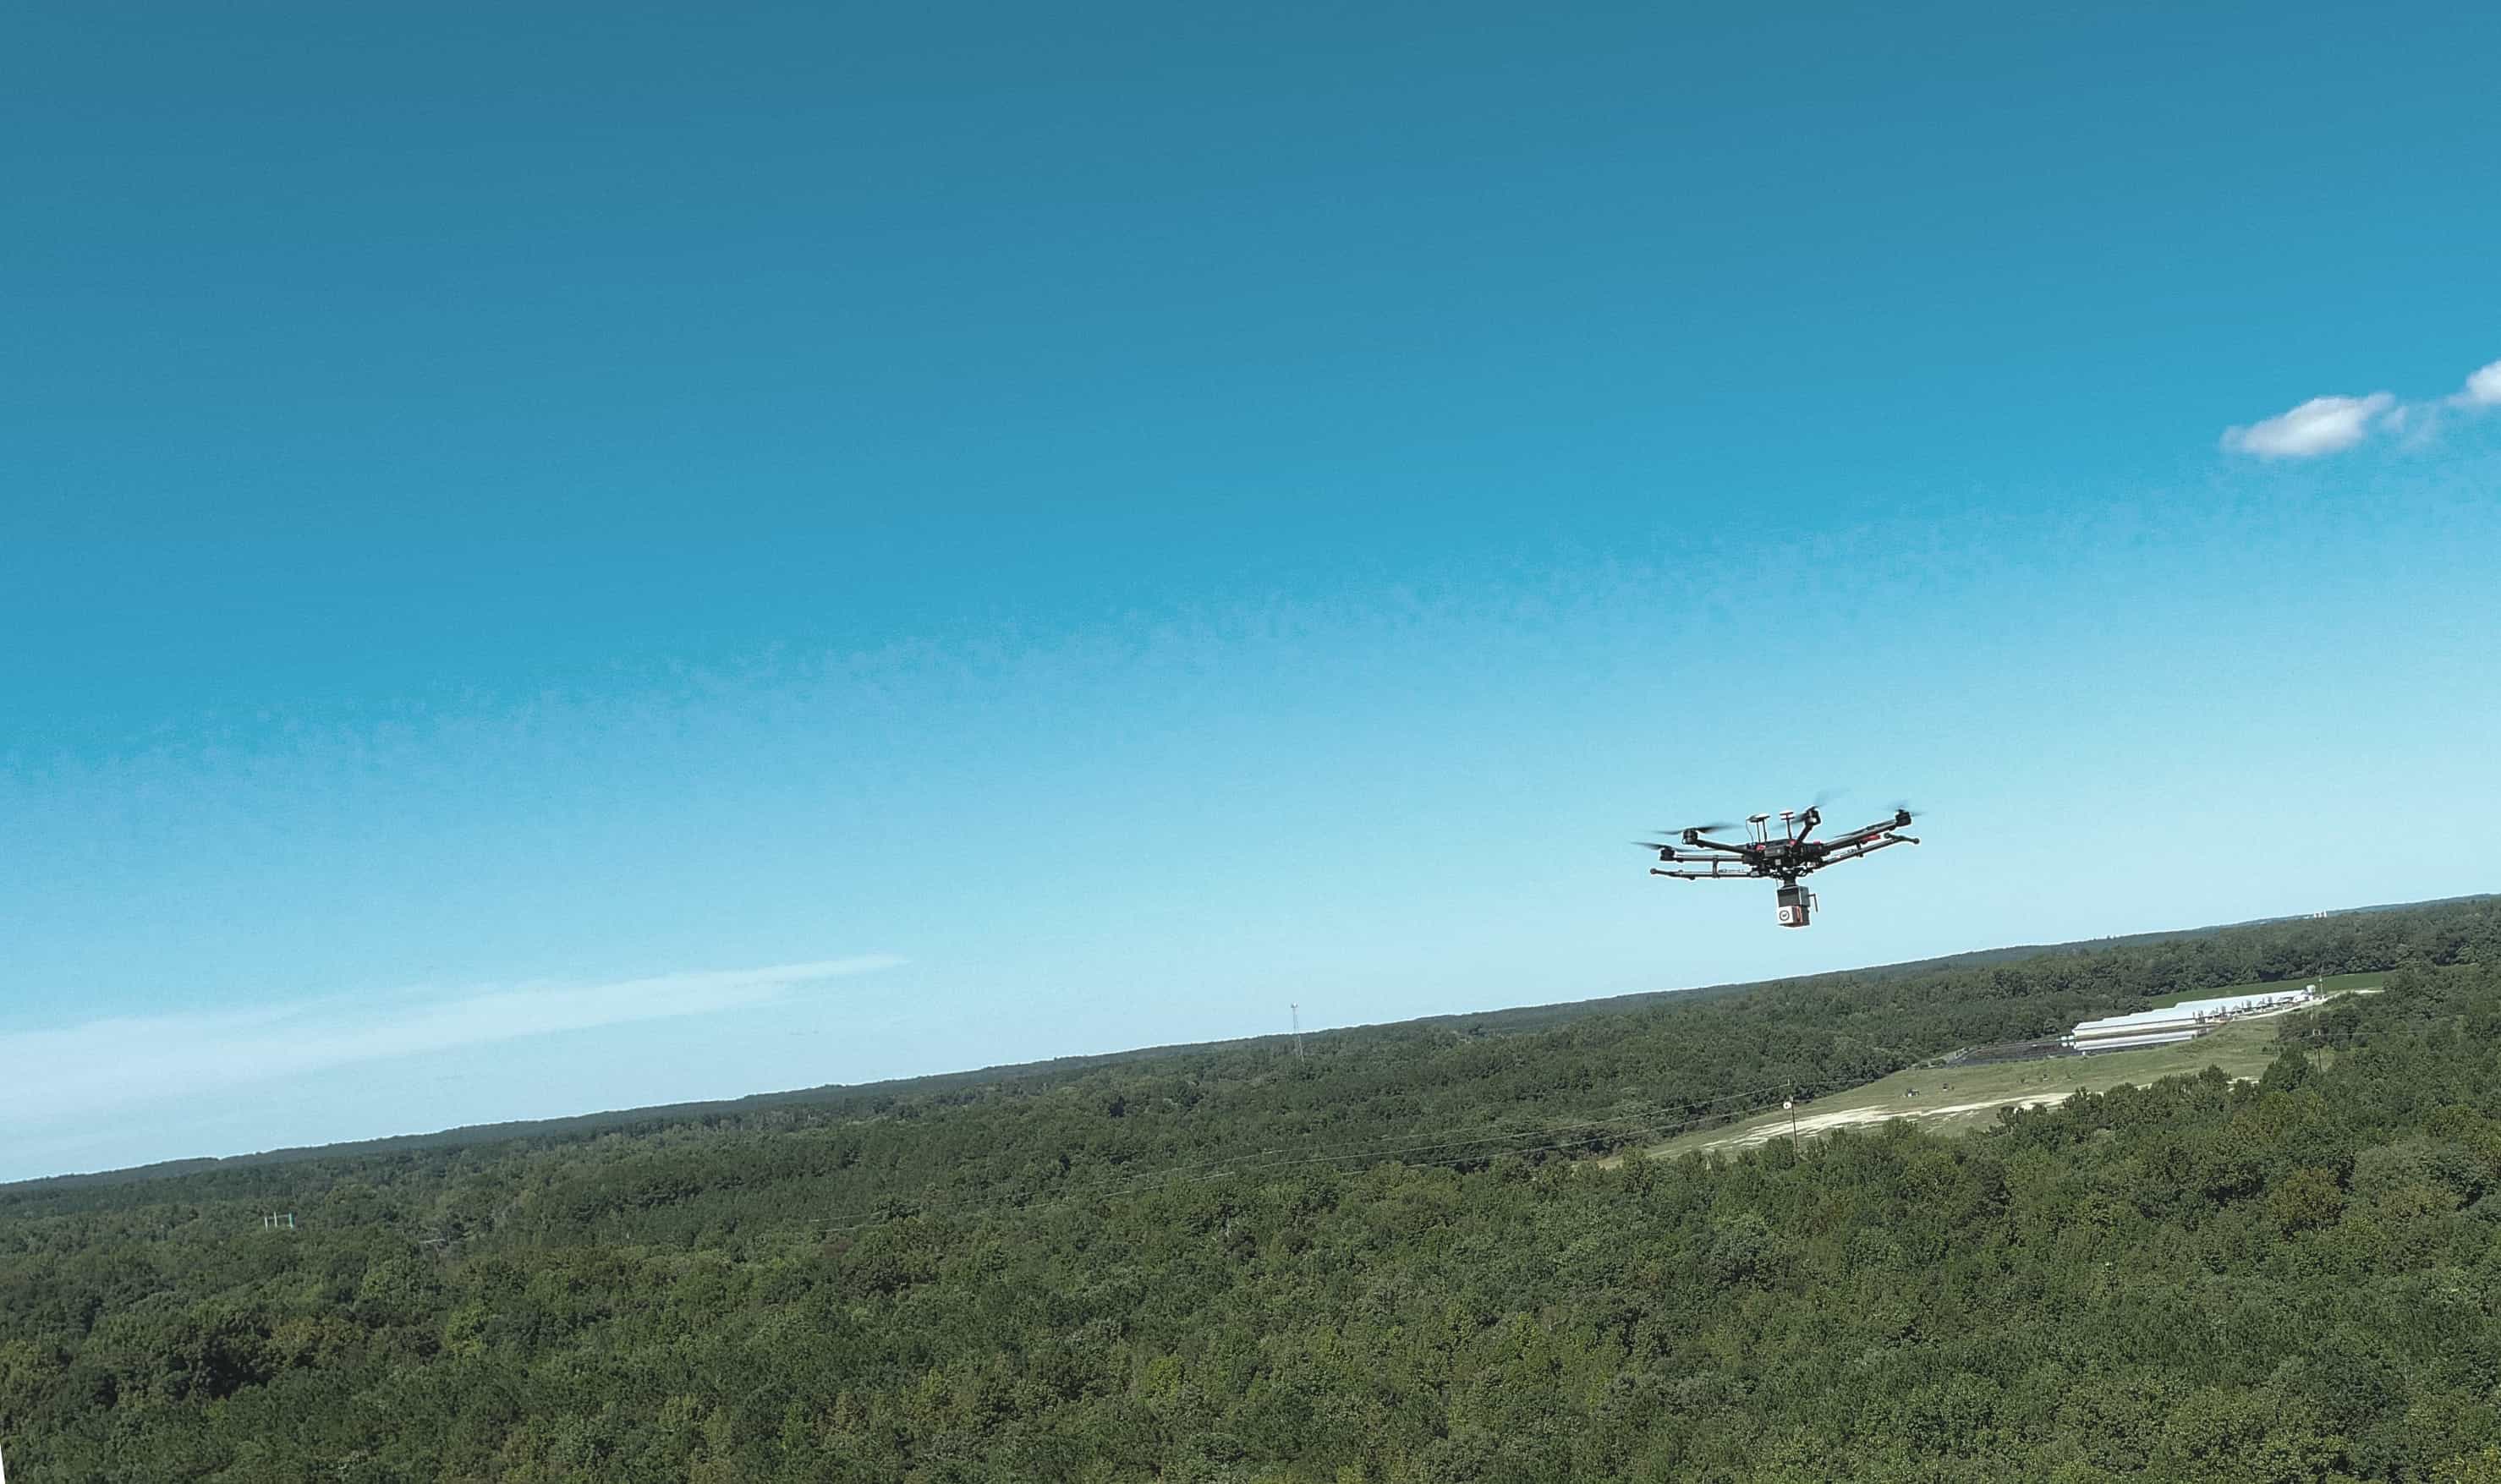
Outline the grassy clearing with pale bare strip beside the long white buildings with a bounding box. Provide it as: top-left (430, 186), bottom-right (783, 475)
top-left (1648, 1004), bottom-right (2321, 1159)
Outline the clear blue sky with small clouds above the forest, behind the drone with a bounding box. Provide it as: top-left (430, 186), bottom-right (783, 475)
top-left (0, 5), bottom-right (2501, 1177)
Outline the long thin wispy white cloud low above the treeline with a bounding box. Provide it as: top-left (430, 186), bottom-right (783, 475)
top-left (0, 955), bottom-right (902, 1127)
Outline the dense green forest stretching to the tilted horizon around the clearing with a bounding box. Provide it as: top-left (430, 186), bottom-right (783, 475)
top-left (0, 900), bottom-right (2501, 1484)
